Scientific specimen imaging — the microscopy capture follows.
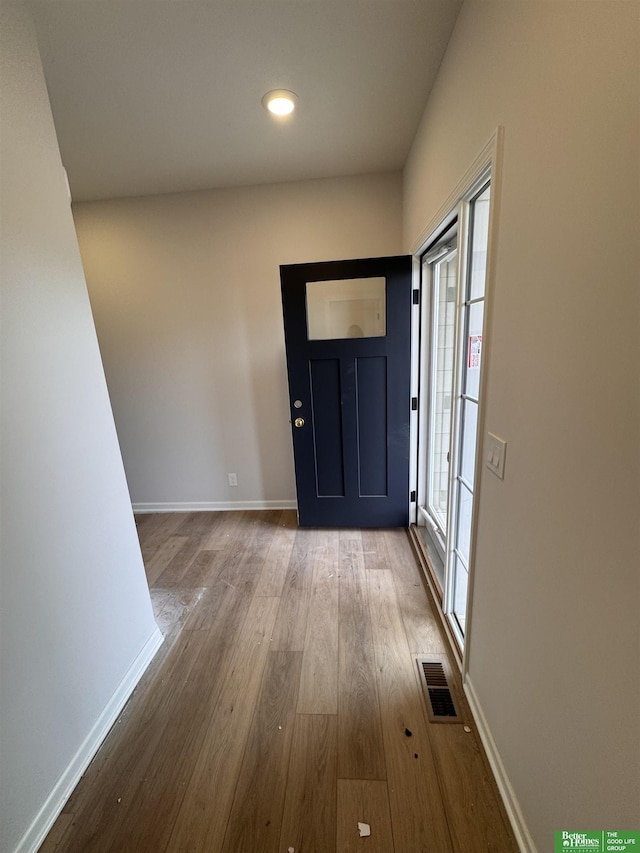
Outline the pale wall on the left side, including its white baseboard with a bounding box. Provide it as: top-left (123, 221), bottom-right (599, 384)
top-left (0, 3), bottom-right (159, 853)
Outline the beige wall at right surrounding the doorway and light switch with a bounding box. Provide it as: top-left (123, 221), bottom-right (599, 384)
top-left (404, 0), bottom-right (640, 851)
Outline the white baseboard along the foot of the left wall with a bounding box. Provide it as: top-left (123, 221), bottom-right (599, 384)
top-left (14, 628), bottom-right (164, 853)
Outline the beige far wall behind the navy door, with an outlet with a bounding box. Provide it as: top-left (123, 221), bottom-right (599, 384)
top-left (74, 174), bottom-right (401, 507)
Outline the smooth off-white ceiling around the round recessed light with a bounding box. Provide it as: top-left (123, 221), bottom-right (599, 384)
top-left (29, 0), bottom-right (461, 200)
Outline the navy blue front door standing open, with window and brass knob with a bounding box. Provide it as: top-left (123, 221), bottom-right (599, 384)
top-left (280, 256), bottom-right (412, 527)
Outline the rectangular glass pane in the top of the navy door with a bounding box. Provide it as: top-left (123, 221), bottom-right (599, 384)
top-left (307, 278), bottom-right (387, 341)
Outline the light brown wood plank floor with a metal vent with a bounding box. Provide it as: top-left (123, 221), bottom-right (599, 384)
top-left (41, 511), bottom-right (518, 853)
